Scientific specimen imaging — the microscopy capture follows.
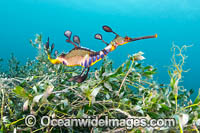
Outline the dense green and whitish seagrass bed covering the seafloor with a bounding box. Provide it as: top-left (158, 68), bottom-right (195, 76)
top-left (0, 35), bottom-right (200, 132)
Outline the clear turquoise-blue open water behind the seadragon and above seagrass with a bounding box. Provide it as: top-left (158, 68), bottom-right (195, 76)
top-left (0, 0), bottom-right (200, 98)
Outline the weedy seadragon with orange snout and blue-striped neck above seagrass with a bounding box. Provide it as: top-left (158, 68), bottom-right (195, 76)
top-left (45, 26), bottom-right (157, 83)
